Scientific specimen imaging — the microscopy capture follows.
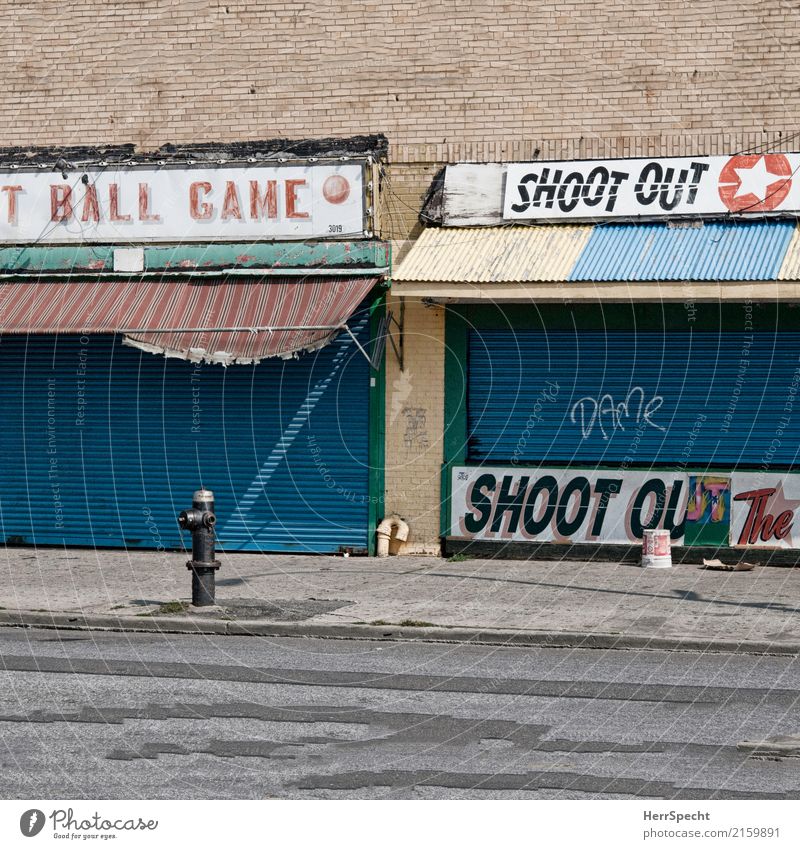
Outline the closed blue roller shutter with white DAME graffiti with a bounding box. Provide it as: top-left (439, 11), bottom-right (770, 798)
top-left (467, 330), bottom-right (800, 468)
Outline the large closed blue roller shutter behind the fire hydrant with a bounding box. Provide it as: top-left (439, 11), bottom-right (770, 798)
top-left (0, 311), bottom-right (369, 552)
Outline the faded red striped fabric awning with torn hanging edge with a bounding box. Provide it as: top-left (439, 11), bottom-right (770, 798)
top-left (0, 275), bottom-right (378, 365)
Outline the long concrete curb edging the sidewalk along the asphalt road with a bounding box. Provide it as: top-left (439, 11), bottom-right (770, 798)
top-left (0, 610), bottom-right (800, 656)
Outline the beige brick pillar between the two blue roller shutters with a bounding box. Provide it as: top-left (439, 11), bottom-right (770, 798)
top-left (386, 292), bottom-right (444, 554)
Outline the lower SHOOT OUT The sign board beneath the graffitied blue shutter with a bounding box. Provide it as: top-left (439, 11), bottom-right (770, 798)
top-left (450, 466), bottom-right (800, 548)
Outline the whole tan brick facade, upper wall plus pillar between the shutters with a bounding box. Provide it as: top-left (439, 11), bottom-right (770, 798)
top-left (0, 0), bottom-right (800, 548)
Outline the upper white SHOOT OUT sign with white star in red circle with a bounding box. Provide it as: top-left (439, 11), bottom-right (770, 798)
top-left (503, 153), bottom-right (800, 221)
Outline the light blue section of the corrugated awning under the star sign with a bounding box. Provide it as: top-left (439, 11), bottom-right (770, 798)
top-left (569, 220), bottom-right (795, 281)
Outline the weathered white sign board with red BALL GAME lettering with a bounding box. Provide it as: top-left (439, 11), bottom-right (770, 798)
top-left (0, 164), bottom-right (365, 244)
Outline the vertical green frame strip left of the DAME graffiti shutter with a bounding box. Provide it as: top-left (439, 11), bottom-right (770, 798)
top-left (439, 306), bottom-right (468, 536)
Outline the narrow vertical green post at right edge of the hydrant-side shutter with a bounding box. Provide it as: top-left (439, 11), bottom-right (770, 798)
top-left (367, 287), bottom-right (386, 557)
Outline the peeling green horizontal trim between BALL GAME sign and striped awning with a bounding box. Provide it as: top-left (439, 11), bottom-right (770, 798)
top-left (0, 240), bottom-right (391, 276)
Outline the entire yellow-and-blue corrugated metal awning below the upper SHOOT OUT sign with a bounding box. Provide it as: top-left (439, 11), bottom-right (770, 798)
top-left (392, 220), bottom-right (800, 300)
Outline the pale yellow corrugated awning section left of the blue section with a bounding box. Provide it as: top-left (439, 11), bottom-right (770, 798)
top-left (392, 225), bottom-right (592, 283)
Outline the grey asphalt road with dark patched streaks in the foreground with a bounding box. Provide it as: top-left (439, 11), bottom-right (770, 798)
top-left (0, 628), bottom-right (800, 799)
